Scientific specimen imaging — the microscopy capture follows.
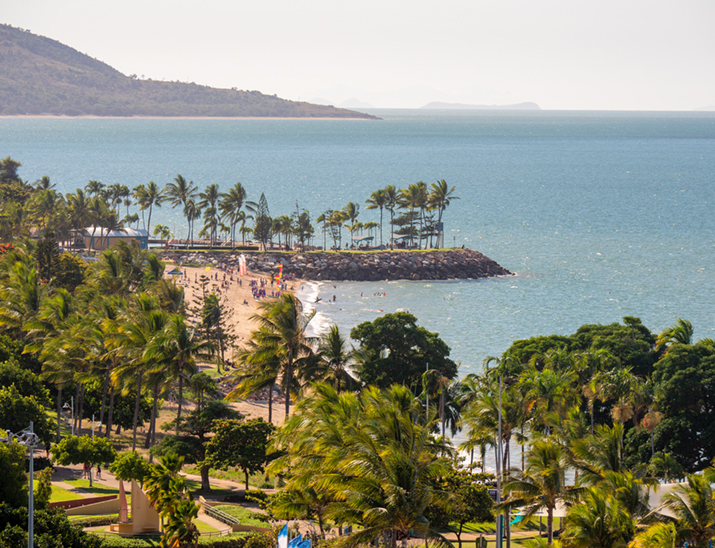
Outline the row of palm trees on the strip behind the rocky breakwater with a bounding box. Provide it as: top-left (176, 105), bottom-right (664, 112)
top-left (0, 158), bottom-right (457, 253)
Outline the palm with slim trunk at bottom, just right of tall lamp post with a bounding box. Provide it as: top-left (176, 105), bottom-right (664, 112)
top-left (503, 440), bottom-right (568, 544)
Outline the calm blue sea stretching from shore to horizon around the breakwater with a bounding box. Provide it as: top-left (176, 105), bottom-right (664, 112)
top-left (0, 111), bottom-right (715, 374)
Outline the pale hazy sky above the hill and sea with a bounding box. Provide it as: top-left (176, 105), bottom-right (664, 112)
top-left (5, 0), bottom-right (715, 110)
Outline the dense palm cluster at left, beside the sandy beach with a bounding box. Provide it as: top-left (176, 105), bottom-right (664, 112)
top-left (0, 244), bottom-right (212, 449)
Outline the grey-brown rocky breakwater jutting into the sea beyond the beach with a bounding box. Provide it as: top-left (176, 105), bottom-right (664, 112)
top-left (162, 249), bottom-right (511, 282)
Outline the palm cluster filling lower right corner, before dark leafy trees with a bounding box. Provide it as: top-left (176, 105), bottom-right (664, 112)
top-left (453, 330), bottom-right (715, 548)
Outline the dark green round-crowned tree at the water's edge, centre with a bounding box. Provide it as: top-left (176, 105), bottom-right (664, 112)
top-left (350, 312), bottom-right (457, 391)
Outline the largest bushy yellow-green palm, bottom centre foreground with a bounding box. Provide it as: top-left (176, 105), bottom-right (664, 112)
top-left (269, 383), bottom-right (450, 548)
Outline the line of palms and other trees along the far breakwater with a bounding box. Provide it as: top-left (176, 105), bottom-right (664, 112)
top-left (0, 157), bottom-right (459, 253)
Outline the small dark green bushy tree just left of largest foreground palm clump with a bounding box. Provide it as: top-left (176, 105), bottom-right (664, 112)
top-left (206, 418), bottom-right (275, 490)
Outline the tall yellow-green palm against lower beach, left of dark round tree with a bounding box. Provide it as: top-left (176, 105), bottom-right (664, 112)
top-left (251, 293), bottom-right (315, 417)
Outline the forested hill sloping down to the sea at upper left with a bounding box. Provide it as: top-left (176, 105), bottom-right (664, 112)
top-left (0, 24), bottom-right (374, 118)
